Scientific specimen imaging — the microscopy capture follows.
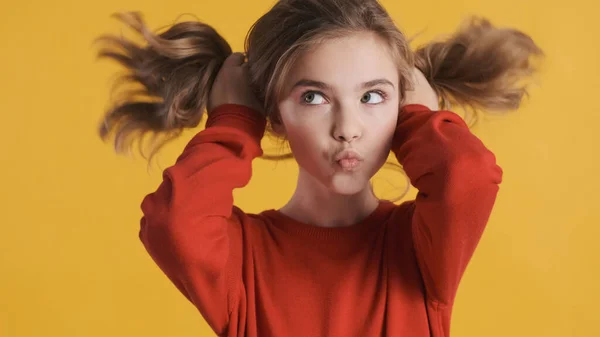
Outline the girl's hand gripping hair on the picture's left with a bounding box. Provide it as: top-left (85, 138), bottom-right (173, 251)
top-left (207, 53), bottom-right (262, 114)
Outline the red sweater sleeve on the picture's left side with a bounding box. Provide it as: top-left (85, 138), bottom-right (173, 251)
top-left (140, 105), bottom-right (265, 334)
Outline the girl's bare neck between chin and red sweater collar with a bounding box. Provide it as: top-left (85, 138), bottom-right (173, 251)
top-left (280, 169), bottom-right (379, 227)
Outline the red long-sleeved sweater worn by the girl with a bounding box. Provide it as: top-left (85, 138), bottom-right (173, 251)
top-left (140, 105), bottom-right (502, 337)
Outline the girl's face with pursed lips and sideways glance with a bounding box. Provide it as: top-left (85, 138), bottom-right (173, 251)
top-left (276, 33), bottom-right (399, 195)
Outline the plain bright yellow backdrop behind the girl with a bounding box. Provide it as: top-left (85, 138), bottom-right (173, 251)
top-left (0, 0), bottom-right (600, 337)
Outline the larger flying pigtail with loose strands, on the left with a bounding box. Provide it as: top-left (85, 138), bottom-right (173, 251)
top-left (97, 13), bottom-right (232, 157)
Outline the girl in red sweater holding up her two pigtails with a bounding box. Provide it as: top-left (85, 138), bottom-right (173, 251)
top-left (100, 0), bottom-right (541, 337)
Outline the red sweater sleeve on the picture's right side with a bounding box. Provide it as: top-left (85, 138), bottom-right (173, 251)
top-left (392, 105), bottom-right (502, 306)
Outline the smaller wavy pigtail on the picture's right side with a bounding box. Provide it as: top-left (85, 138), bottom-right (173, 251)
top-left (415, 18), bottom-right (543, 116)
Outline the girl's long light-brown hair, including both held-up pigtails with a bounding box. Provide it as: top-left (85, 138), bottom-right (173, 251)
top-left (98, 0), bottom-right (542, 155)
